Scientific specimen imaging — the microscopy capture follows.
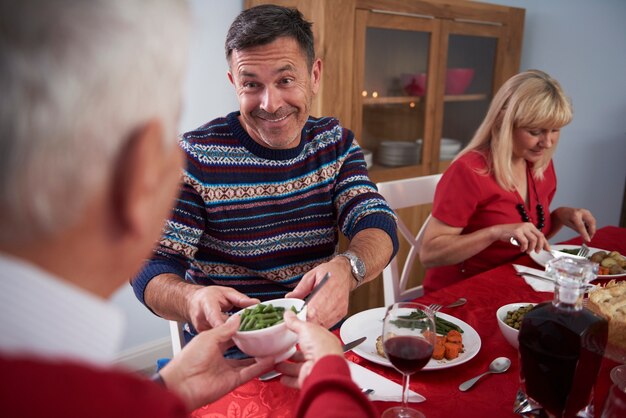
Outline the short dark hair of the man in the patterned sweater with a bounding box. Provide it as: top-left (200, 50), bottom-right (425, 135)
top-left (225, 4), bottom-right (315, 70)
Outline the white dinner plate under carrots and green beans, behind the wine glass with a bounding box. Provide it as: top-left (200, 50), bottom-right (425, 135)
top-left (339, 307), bottom-right (480, 370)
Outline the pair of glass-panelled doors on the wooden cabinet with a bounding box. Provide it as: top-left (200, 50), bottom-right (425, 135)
top-left (352, 11), bottom-right (506, 181)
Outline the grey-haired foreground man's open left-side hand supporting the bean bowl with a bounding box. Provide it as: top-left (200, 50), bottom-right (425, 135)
top-left (160, 315), bottom-right (274, 411)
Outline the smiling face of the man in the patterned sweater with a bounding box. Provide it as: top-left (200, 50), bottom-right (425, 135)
top-left (228, 37), bottom-right (321, 149)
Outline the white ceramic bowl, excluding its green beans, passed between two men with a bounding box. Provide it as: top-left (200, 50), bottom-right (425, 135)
top-left (233, 298), bottom-right (306, 363)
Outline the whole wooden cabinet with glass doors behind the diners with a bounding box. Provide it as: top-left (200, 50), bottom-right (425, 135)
top-left (245, 0), bottom-right (524, 311)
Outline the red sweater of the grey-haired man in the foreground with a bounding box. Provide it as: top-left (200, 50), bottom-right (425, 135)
top-left (0, 356), bottom-right (378, 418)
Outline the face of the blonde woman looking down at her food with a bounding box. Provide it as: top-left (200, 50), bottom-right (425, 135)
top-left (513, 128), bottom-right (561, 163)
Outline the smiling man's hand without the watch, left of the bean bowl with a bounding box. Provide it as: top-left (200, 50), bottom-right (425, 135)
top-left (187, 286), bottom-right (260, 332)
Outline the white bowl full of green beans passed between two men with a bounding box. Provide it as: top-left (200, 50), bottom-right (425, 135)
top-left (233, 298), bottom-right (306, 363)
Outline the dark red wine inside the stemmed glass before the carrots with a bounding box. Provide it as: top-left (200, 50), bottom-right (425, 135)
top-left (384, 335), bottom-right (433, 374)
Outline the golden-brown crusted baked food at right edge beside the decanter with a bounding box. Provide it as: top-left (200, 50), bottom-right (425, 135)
top-left (587, 280), bottom-right (626, 350)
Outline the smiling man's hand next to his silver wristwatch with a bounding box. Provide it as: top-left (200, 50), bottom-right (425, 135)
top-left (285, 257), bottom-right (356, 328)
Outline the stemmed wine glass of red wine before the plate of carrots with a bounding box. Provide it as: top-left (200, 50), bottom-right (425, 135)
top-left (382, 302), bottom-right (436, 418)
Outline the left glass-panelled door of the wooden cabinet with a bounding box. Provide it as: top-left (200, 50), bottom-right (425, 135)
top-left (353, 12), bottom-right (435, 177)
